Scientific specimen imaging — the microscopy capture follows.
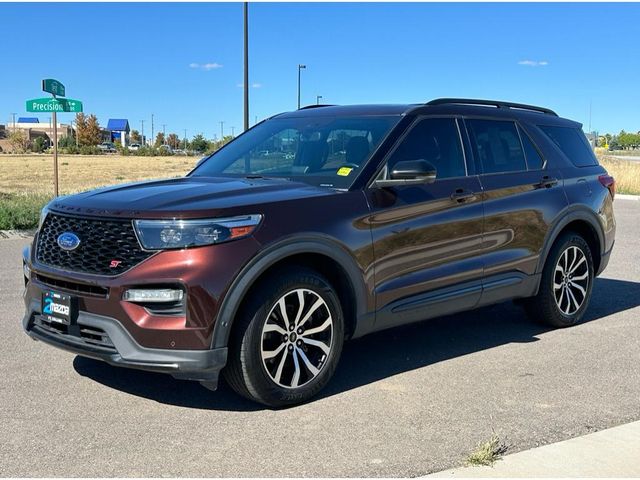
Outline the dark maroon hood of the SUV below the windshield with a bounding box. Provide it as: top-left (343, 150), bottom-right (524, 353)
top-left (49, 176), bottom-right (337, 218)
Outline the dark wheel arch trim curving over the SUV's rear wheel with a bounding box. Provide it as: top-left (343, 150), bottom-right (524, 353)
top-left (536, 208), bottom-right (605, 273)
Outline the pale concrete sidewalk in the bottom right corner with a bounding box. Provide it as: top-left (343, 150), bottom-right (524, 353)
top-left (428, 421), bottom-right (640, 478)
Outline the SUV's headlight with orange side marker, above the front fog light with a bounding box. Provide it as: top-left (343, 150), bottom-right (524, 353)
top-left (133, 215), bottom-right (262, 250)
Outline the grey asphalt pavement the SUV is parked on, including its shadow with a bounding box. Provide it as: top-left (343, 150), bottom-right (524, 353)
top-left (0, 199), bottom-right (640, 477)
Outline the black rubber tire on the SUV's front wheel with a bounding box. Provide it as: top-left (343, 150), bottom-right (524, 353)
top-left (223, 268), bottom-right (344, 407)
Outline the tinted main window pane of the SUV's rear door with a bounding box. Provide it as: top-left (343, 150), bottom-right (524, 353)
top-left (467, 120), bottom-right (527, 173)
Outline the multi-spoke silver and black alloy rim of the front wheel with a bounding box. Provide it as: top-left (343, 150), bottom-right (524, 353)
top-left (260, 288), bottom-right (333, 388)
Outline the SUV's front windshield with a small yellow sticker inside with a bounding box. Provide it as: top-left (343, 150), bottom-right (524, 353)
top-left (191, 115), bottom-right (401, 188)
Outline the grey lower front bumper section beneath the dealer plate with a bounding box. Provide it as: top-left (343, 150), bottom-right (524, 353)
top-left (22, 299), bottom-right (227, 389)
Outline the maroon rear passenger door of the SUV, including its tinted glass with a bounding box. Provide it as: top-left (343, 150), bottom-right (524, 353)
top-left (465, 118), bottom-right (567, 304)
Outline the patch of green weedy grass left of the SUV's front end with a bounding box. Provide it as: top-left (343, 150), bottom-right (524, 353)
top-left (0, 193), bottom-right (51, 230)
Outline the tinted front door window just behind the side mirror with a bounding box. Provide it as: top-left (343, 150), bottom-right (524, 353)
top-left (387, 118), bottom-right (466, 178)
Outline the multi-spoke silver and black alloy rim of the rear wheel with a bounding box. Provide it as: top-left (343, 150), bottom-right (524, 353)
top-left (553, 245), bottom-right (590, 315)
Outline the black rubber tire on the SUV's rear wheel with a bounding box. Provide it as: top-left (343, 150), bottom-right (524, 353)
top-left (523, 232), bottom-right (595, 328)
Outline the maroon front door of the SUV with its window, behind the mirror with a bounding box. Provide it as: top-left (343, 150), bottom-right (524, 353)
top-left (367, 117), bottom-right (483, 329)
